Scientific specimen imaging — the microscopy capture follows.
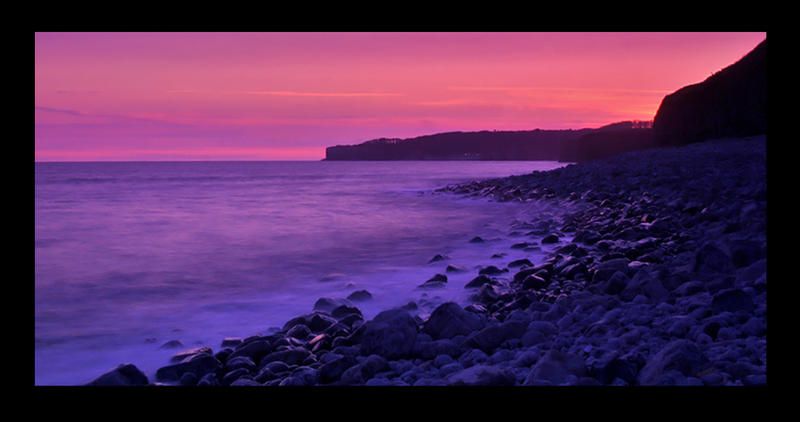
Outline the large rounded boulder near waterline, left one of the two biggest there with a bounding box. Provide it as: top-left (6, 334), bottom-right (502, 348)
top-left (359, 308), bottom-right (418, 359)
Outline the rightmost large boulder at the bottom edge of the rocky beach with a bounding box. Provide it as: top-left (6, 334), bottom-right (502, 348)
top-left (639, 339), bottom-right (709, 385)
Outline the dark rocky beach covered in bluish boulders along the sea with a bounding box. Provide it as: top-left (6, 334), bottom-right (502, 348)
top-left (84, 136), bottom-right (766, 386)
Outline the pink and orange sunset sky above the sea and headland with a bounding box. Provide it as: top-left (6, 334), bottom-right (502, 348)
top-left (35, 32), bottom-right (766, 161)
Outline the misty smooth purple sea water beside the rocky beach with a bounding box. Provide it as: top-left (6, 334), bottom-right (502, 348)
top-left (34, 161), bottom-right (564, 385)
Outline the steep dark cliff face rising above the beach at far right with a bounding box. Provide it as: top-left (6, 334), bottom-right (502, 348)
top-left (653, 40), bottom-right (767, 145)
